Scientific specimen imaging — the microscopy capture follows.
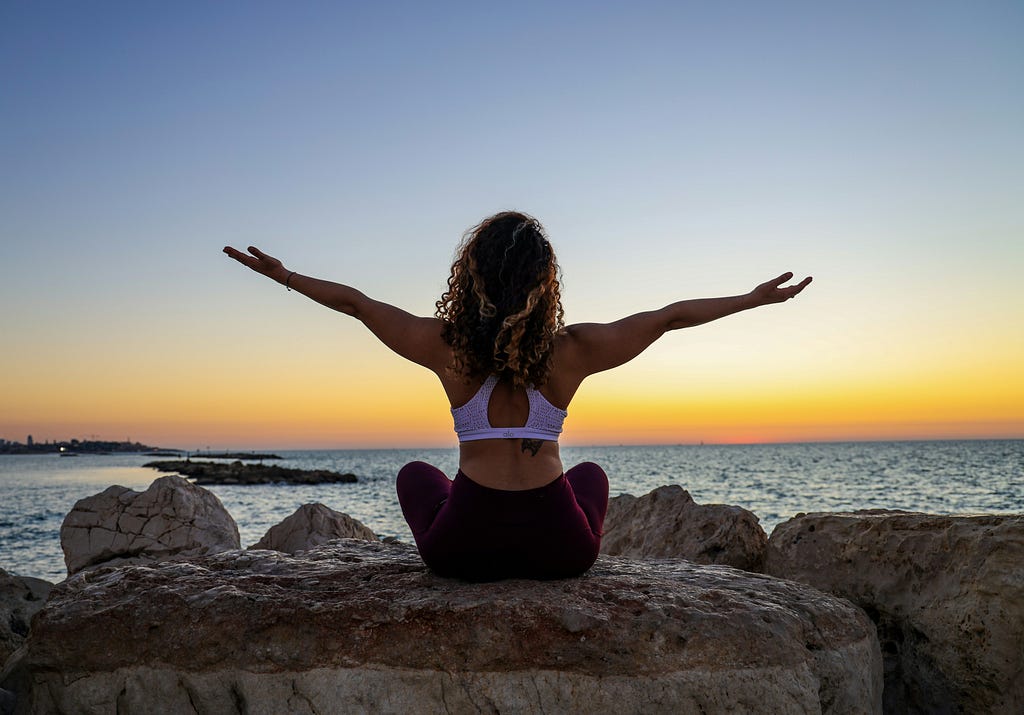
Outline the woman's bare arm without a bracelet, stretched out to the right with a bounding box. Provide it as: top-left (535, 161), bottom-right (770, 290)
top-left (565, 272), bottom-right (811, 380)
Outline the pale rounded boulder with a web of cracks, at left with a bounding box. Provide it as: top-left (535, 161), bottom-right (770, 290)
top-left (60, 476), bottom-right (240, 575)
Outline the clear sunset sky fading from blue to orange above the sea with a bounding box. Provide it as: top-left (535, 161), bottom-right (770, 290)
top-left (0, 0), bottom-right (1024, 449)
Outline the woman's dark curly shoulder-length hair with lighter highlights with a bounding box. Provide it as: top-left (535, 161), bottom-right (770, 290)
top-left (435, 211), bottom-right (565, 387)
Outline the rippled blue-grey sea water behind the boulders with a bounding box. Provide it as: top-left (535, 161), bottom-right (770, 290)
top-left (0, 439), bottom-right (1024, 581)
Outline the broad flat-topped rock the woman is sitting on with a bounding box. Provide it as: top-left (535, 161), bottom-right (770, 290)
top-left (0, 540), bottom-right (881, 714)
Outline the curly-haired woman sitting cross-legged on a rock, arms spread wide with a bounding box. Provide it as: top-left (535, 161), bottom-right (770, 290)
top-left (224, 211), bottom-right (811, 580)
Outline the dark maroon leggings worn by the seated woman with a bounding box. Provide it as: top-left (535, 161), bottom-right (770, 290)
top-left (397, 462), bottom-right (608, 581)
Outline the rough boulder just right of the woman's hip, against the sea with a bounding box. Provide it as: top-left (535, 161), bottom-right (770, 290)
top-left (601, 485), bottom-right (768, 572)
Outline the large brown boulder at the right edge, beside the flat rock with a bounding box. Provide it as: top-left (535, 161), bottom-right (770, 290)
top-left (765, 510), bottom-right (1024, 715)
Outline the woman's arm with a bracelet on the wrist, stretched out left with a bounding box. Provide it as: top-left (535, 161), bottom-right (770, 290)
top-left (224, 246), bottom-right (449, 372)
